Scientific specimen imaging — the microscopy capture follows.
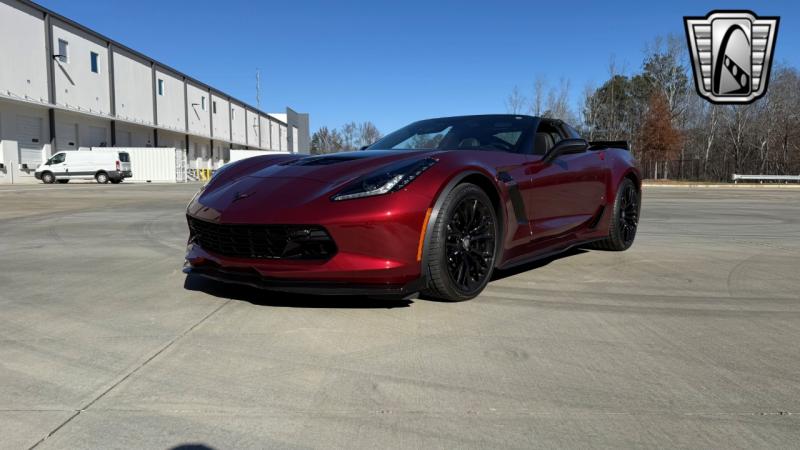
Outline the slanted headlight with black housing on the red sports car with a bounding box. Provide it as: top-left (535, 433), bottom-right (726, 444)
top-left (331, 158), bottom-right (436, 201)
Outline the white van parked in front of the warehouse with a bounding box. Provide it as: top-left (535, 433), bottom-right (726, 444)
top-left (34, 150), bottom-right (132, 184)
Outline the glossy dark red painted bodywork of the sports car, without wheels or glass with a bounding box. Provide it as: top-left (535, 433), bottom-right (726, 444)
top-left (186, 116), bottom-right (640, 293)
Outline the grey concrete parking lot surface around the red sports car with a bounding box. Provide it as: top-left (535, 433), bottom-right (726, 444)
top-left (0, 184), bottom-right (800, 449)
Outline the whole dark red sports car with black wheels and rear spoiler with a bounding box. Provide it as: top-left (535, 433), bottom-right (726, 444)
top-left (185, 115), bottom-right (641, 301)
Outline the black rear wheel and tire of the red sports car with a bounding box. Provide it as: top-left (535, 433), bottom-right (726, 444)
top-left (593, 178), bottom-right (642, 252)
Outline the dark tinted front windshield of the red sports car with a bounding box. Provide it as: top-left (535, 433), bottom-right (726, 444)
top-left (369, 115), bottom-right (535, 152)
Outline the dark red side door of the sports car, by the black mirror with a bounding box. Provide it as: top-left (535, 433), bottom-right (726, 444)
top-left (530, 122), bottom-right (605, 241)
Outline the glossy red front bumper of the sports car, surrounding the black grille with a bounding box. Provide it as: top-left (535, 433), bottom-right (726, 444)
top-left (186, 192), bottom-right (432, 288)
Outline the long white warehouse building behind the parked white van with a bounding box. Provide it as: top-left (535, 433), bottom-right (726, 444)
top-left (0, 0), bottom-right (310, 183)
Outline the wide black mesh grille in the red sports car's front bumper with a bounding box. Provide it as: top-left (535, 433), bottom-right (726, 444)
top-left (187, 216), bottom-right (336, 260)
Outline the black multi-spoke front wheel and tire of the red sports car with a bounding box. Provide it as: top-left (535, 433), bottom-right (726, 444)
top-left (422, 183), bottom-right (500, 302)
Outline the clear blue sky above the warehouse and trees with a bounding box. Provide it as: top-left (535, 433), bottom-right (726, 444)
top-left (40, 0), bottom-right (800, 133)
